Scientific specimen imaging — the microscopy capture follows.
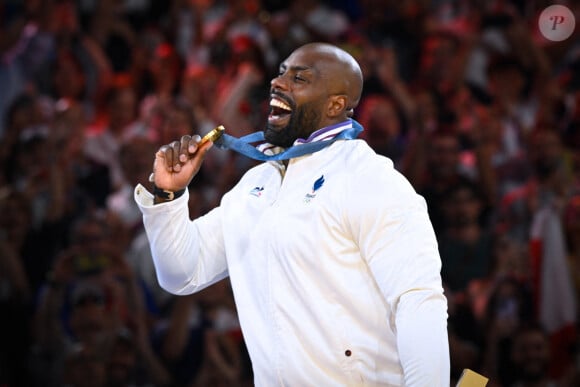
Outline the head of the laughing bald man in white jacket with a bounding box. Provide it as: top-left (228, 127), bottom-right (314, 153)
top-left (264, 44), bottom-right (362, 147)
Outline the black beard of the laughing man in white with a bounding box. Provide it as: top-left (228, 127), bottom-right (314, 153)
top-left (264, 105), bottom-right (320, 148)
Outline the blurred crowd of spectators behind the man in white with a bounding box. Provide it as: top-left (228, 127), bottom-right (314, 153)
top-left (0, 0), bottom-right (580, 387)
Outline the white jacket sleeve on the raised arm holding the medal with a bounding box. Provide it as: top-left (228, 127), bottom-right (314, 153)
top-left (134, 184), bottom-right (228, 294)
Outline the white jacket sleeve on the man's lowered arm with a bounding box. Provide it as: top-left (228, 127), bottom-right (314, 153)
top-left (348, 161), bottom-right (450, 387)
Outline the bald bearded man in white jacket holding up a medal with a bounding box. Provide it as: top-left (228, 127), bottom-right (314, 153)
top-left (135, 43), bottom-right (449, 387)
